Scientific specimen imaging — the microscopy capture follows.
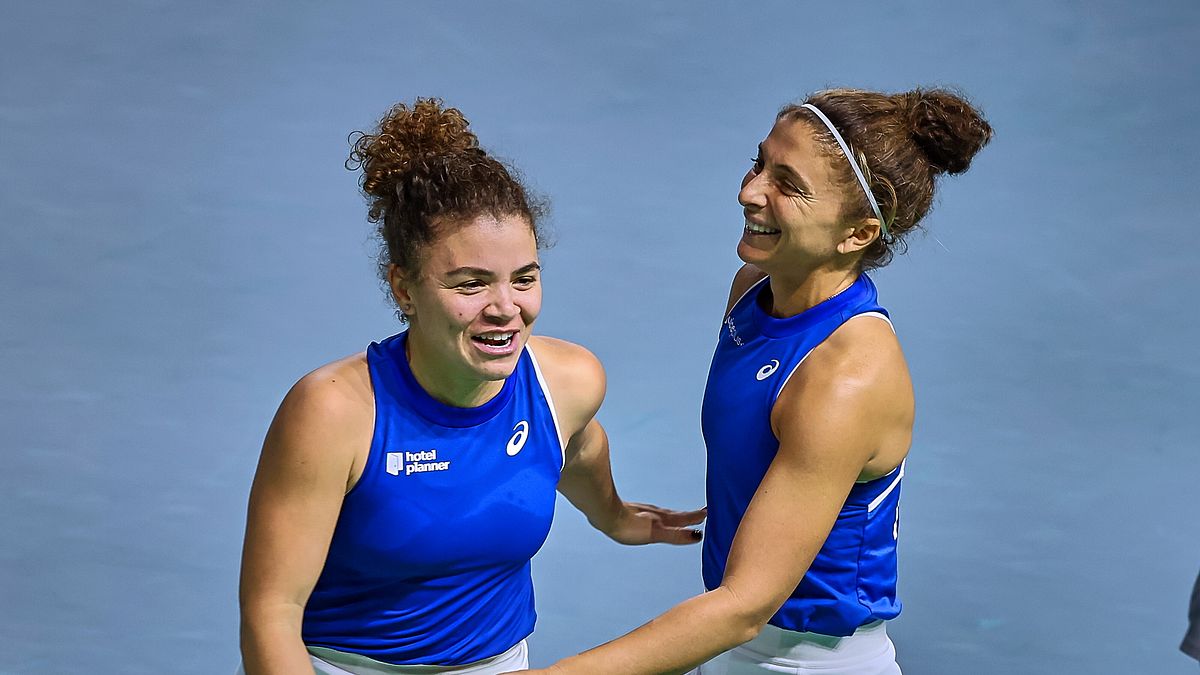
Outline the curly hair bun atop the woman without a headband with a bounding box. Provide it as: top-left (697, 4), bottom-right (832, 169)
top-left (346, 98), bottom-right (484, 204)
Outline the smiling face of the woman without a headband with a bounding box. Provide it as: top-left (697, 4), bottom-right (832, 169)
top-left (389, 215), bottom-right (541, 406)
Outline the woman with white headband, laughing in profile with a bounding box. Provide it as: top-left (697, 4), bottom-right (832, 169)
top-left (525, 89), bottom-right (991, 675)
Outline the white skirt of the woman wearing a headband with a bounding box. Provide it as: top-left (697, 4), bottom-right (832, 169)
top-left (689, 621), bottom-right (900, 675)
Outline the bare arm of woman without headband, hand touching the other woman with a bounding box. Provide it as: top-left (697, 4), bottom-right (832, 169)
top-left (533, 338), bottom-right (704, 544)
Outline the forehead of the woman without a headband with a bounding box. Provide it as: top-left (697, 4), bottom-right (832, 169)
top-left (421, 215), bottom-right (538, 274)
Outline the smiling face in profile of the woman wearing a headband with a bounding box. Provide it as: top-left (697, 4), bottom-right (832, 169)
top-left (738, 118), bottom-right (860, 276)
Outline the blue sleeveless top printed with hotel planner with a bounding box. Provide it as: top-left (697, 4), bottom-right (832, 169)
top-left (302, 333), bottom-right (563, 665)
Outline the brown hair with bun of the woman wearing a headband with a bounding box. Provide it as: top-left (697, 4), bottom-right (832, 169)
top-left (776, 89), bottom-right (992, 270)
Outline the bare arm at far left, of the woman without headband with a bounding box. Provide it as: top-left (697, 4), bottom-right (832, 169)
top-left (239, 362), bottom-right (373, 675)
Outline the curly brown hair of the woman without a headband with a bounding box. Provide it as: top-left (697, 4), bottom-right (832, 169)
top-left (346, 98), bottom-right (547, 309)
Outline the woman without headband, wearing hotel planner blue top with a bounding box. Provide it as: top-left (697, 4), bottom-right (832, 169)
top-left (240, 100), bottom-right (703, 675)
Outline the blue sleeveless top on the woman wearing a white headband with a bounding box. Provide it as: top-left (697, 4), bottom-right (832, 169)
top-left (701, 274), bottom-right (904, 635)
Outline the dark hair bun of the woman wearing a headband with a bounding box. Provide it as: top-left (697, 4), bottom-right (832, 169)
top-left (898, 89), bottom-right (991, 174)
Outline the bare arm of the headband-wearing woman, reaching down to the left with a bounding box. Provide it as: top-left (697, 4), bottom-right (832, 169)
top-left (535, 317), bottom-right (911, 675)
